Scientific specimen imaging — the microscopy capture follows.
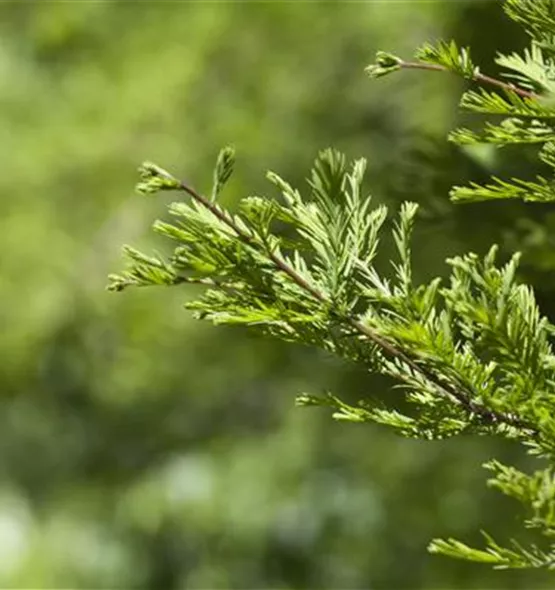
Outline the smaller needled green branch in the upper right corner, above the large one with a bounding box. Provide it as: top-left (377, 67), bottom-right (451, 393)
top-left (367, 0), bottom-right (555, 202)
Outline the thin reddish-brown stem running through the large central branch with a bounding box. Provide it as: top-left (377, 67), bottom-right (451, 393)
top-left (180, 182), bottom-right (537, 434)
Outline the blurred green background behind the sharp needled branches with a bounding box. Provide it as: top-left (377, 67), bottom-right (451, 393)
top-left (0, 0), bottom-right (555, 590)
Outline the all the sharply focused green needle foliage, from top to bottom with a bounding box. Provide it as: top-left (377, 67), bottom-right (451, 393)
top-left (109, 0), bottom-right (555, 580)
